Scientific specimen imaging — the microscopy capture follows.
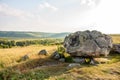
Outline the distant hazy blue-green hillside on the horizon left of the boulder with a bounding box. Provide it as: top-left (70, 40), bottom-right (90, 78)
top-left (0, 31), bottom-right (69, 38)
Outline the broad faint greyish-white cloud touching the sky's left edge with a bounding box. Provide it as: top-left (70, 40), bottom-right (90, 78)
top-left (0, 3), bottom-right (34, 18)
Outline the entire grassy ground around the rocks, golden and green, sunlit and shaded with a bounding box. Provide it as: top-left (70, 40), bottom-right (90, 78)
top-left (0, 36), bottom-right (120, 80)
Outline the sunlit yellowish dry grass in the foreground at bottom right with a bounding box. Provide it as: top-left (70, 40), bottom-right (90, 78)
top-left (47, 62), bottom-right (120, 80)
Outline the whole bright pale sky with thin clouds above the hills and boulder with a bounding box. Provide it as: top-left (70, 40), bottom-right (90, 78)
top-left (0, 0), bottom-right (120, 34)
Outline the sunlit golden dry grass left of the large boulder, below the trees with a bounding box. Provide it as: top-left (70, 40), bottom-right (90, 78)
top-left (0, 45), bottom-right (57, 67)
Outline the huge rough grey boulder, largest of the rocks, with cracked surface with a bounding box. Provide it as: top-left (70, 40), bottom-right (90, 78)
top-left (64, 30), bottom-right (112, 57)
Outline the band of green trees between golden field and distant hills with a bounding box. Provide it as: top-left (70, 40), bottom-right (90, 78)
top-left (0, 39), bottom-right (63, 48)
